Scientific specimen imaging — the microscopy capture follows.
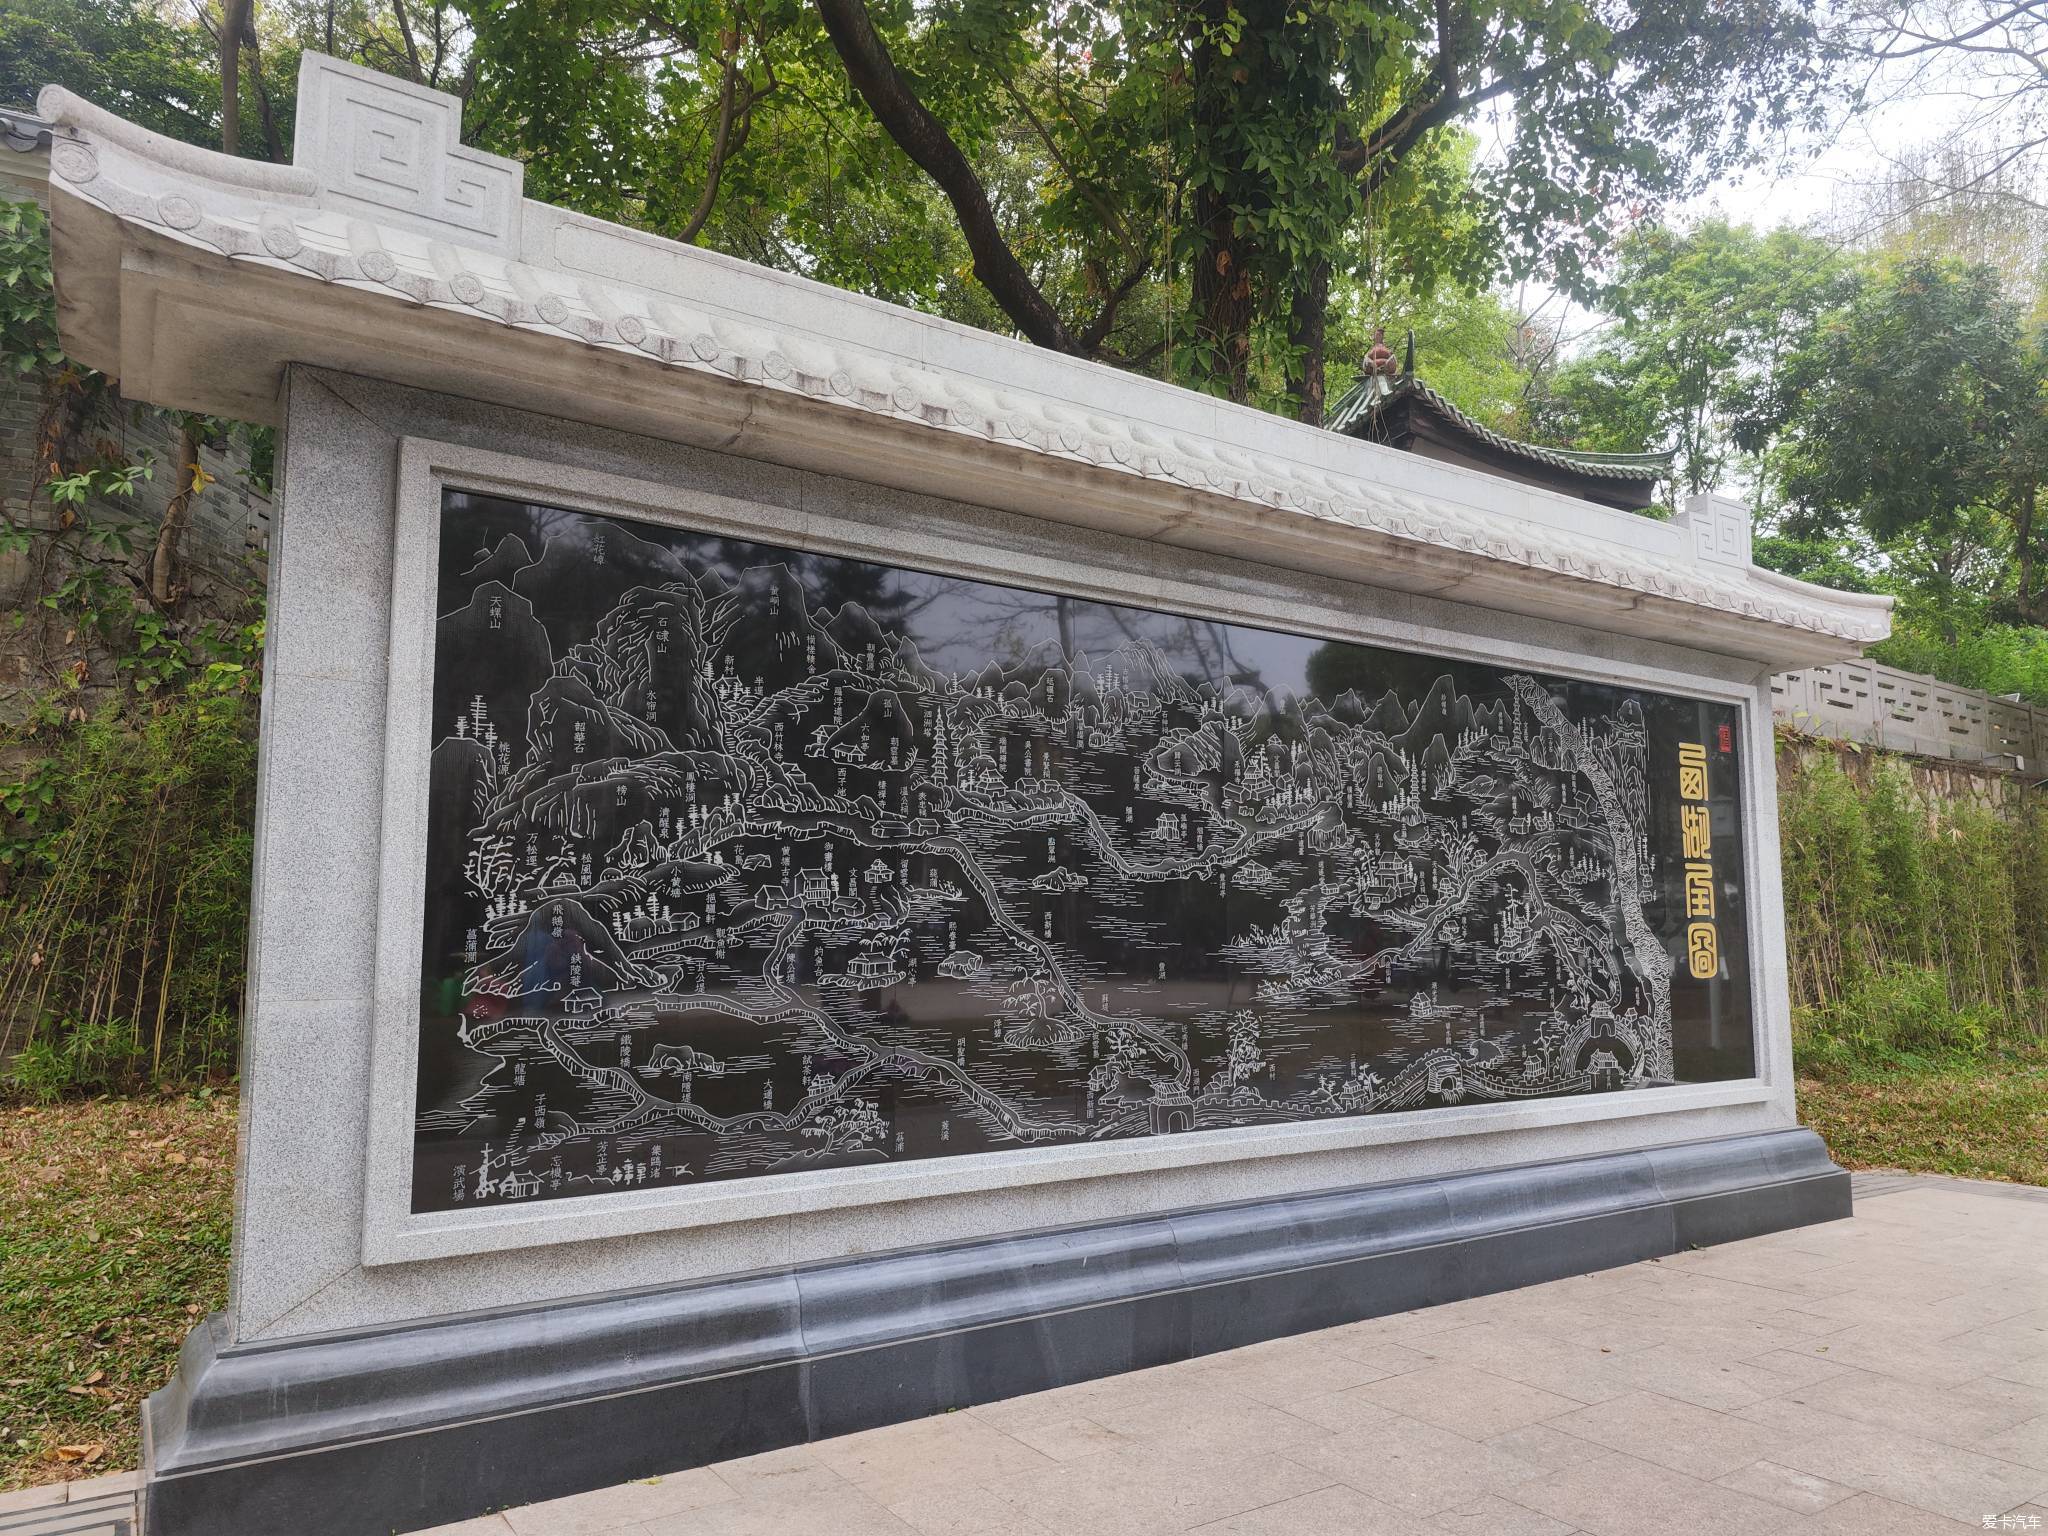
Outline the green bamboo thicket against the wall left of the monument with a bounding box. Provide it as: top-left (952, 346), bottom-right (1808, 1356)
top-left (0, 625), bottom-right (262, 1100)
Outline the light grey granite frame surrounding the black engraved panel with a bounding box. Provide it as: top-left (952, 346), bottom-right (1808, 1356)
top-left (360, 436), bottom-right (1788, 1268)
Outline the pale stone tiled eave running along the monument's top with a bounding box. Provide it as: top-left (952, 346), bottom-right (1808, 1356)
top-left (39, 86), bottom-right (1890, 651)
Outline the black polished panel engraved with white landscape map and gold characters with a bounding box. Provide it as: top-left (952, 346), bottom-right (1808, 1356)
top-left (414, 494), bottom-right (1749, 1210)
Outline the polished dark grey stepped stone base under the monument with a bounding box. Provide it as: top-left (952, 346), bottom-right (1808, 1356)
top-left (143, 1128), bottom-right (1849, 1536)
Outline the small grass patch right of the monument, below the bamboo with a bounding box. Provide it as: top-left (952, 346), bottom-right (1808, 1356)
top-left (1798, 1051), bottom-right (2048, 1184)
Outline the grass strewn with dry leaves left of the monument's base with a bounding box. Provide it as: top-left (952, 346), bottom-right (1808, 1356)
top-left (0, 1092), bottom-right (236, 1489)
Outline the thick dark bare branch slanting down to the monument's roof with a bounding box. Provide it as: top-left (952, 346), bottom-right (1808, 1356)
top-left (813, 0), bottom-right (1085, 354)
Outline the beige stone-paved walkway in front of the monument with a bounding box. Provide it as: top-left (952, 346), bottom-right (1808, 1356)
top-left (0, 1176), bottom-right (2048, 1536)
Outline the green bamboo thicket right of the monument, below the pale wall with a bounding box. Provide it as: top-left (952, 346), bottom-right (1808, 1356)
top-left (1778, 750), bottom-right (2048, 1065)
